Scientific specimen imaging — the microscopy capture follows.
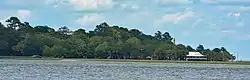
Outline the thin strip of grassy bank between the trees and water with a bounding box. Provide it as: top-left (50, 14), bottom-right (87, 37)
top-left (0, 56), bottom-right (250, 65)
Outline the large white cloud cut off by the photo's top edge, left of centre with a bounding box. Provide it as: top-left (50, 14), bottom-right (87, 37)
top-left (70, 0), bottom-right (114, 10)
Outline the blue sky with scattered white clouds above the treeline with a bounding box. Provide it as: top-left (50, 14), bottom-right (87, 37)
top-left (0, 0), bottom-right (250, 61)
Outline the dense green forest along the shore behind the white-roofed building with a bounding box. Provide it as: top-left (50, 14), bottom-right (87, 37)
top-left (0, 17), bottom-right (235, 61)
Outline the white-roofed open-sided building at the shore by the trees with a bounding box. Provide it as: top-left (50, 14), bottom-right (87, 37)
top-left (186, 52), bottom-right (207, 61)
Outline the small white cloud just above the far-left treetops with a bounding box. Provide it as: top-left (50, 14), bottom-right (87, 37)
top-left (16, 10), bottom-right (31, 20)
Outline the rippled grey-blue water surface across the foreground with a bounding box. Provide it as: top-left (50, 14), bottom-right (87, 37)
top-left (0, 60), bottom-right (250, 80)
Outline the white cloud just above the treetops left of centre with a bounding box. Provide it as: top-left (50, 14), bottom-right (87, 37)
top-left (76, 14), bottom-right (104, 27)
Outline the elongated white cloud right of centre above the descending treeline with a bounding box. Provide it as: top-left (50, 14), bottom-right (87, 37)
top-left (162, 11), bottom-right (195, 24)
